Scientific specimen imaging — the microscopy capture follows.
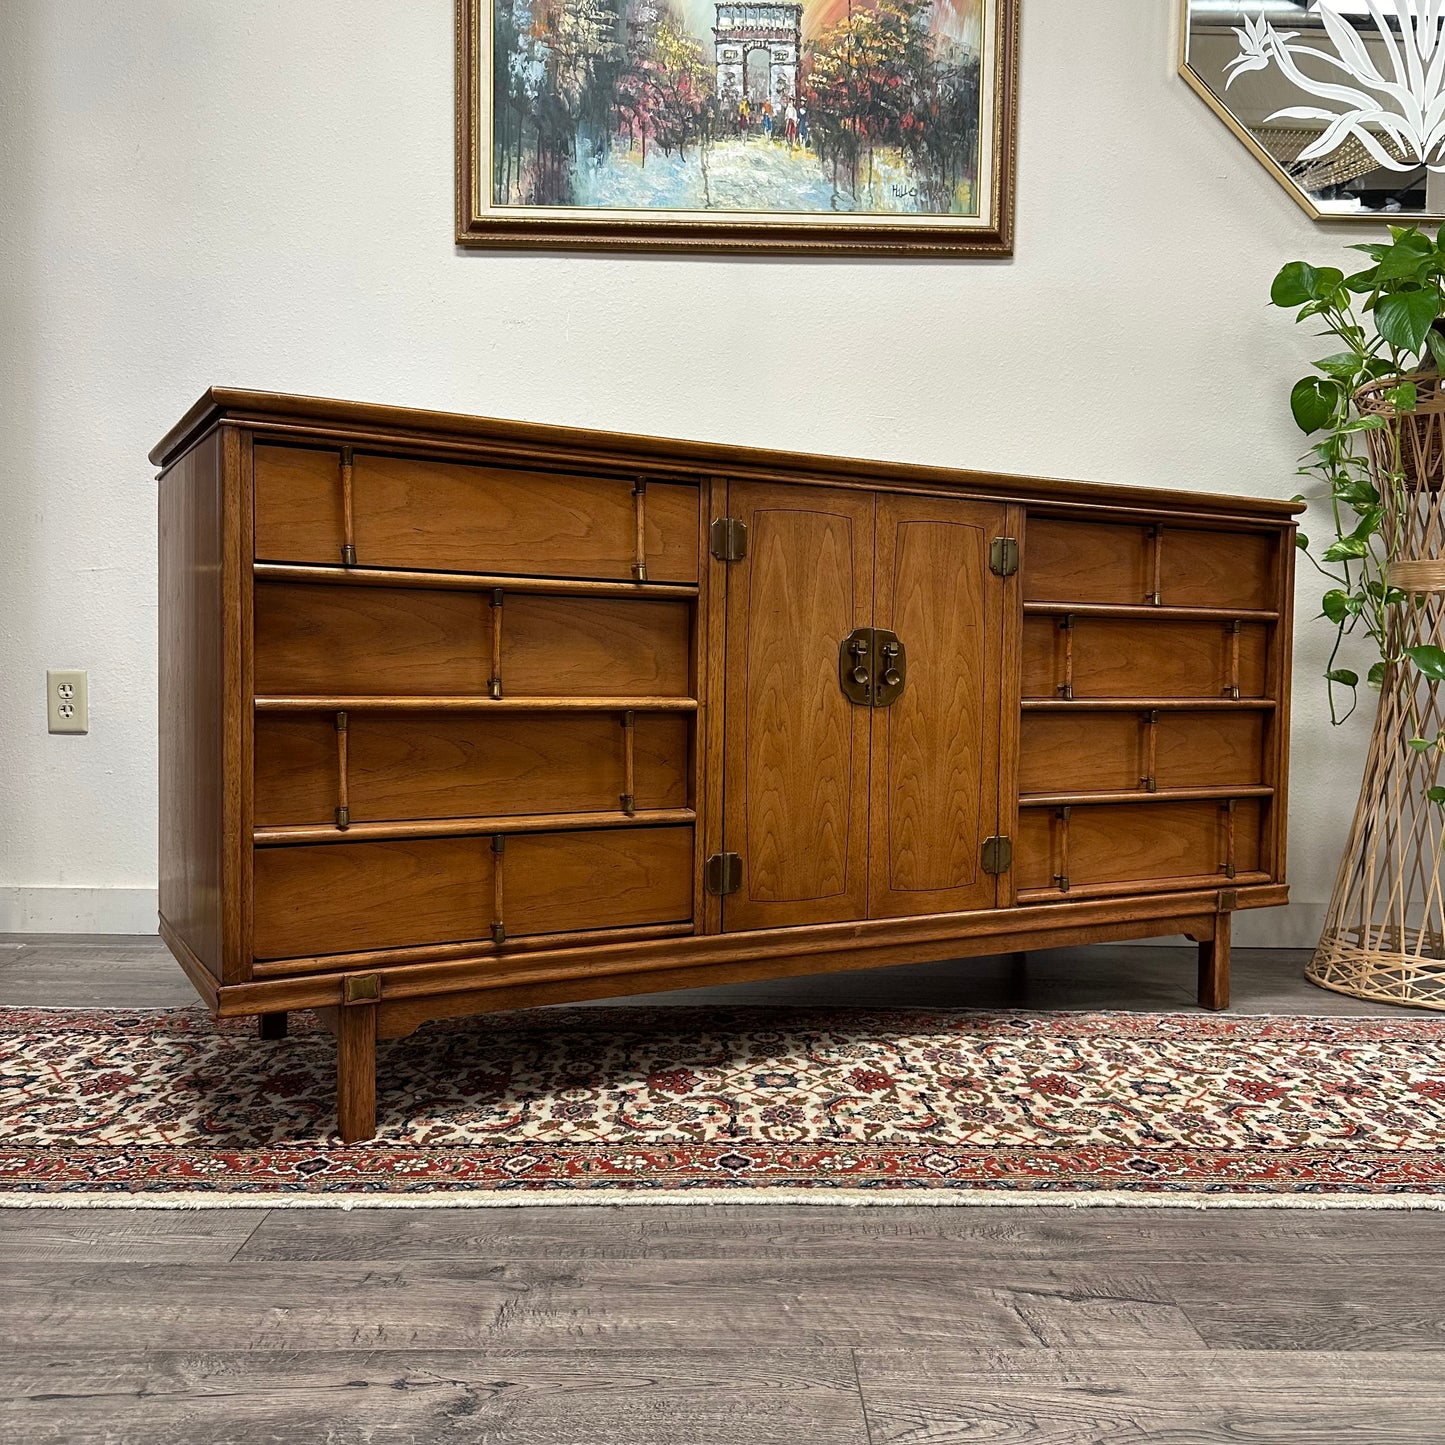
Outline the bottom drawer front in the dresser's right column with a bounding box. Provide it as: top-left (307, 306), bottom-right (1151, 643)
top-left (1013, 798), bottom-right (1263, 892)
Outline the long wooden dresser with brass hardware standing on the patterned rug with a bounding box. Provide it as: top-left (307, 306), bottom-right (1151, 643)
top-left (152, 390), bottom-right (1298, 1140)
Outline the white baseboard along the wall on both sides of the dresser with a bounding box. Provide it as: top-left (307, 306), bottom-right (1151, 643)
top-left (0, 887), bottom-right (1325, 948)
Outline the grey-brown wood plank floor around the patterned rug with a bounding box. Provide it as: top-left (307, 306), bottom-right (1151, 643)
top-left (0, 936), bottom-right (1445, 1445)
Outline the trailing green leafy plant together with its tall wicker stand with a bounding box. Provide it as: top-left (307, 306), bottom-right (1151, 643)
top-left (1270, 227), bottom-right (1445, 1009)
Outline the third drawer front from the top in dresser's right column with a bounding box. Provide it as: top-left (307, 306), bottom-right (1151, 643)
top-left (1019, 711), bottom-right (1264, 793)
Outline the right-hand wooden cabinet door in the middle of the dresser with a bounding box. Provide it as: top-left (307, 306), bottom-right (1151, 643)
top-left (868, 496), bottom-right (1007, 918)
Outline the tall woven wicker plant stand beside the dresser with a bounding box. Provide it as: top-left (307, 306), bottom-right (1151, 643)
top-left (1305, 376), bottom-right (1445, 1010)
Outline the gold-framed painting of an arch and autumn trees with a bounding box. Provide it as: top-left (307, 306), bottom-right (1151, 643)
top-left (457, 0), bottom-right (1020, 256)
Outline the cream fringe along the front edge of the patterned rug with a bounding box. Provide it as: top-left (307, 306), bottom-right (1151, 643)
top-left (0, 1189), bottom-right (1445, 1212)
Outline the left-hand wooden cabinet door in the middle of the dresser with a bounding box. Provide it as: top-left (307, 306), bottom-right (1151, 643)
top-left (723, 483), bottom-right (874, 932)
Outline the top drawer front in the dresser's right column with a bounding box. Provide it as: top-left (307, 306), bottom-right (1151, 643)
top-left (1023, 517), bottom-right (1277, 611)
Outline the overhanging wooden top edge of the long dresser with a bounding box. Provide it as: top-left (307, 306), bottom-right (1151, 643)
top-left (150, 386), bottom-right (1305, 522)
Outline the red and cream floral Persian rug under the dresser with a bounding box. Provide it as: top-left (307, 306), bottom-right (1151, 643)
top-left (0, 1007), bottom-right (1445, 1208)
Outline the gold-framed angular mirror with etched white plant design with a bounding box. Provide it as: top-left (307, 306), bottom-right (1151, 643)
top-left (1179, 0), bottom-right (1445, 223)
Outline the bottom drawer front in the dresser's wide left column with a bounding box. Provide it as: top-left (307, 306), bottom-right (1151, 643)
top-left (254, 827), bottom-right (692, 959)
